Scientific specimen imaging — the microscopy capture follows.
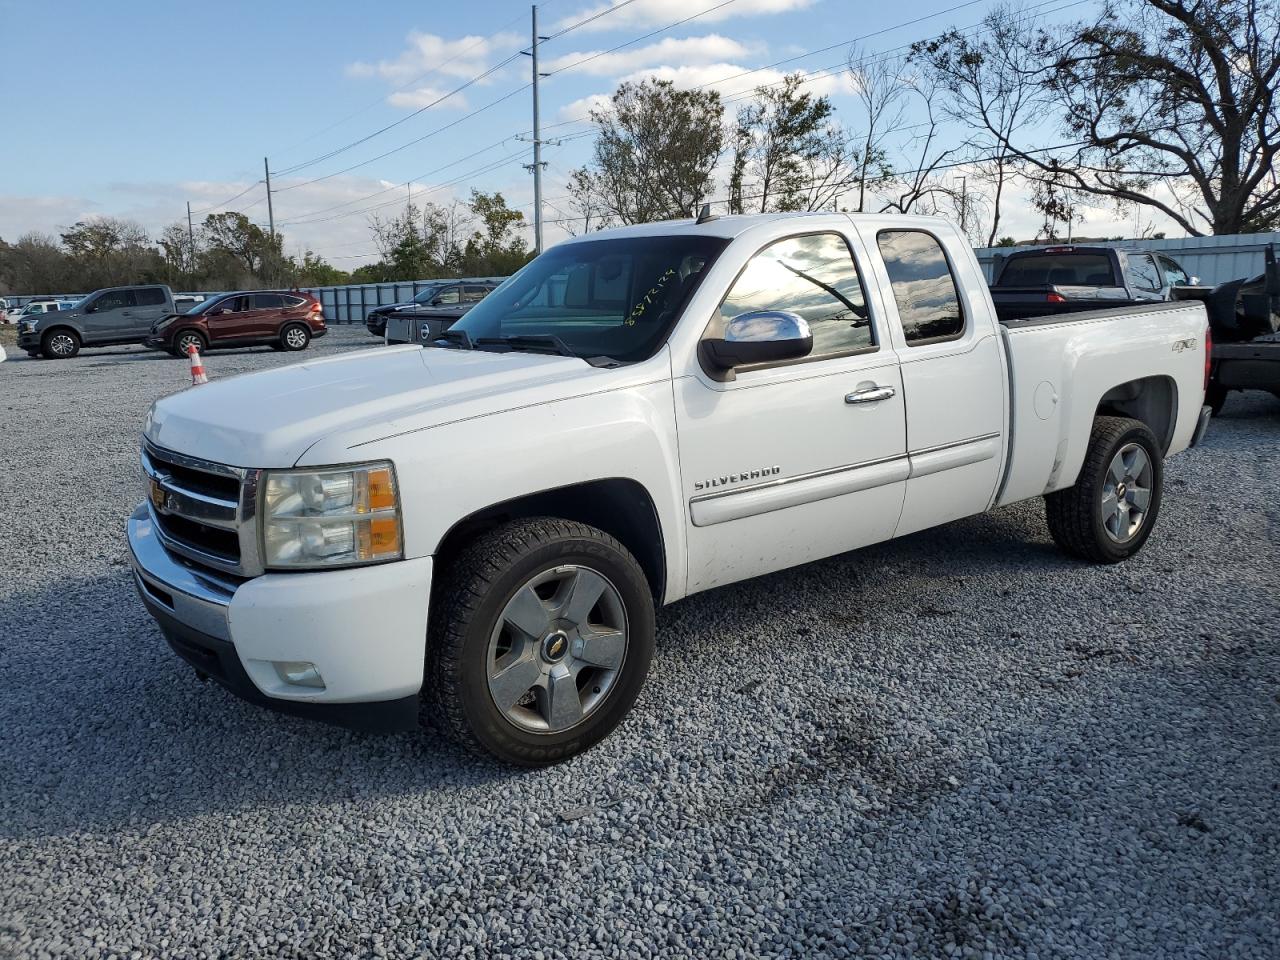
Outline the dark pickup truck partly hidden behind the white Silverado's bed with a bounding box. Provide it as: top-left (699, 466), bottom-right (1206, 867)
top-left (991, 247), bottom-right (1198, 320)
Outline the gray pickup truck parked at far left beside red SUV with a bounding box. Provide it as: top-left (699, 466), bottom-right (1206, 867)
top-left (18, 283), bottom-right (175, 360)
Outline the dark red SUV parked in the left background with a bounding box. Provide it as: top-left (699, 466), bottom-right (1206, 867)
top-left (145, 291), bottom-right (328, 357)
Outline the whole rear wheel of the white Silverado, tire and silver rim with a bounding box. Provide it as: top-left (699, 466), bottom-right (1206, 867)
top-left (1044, 417), bottom-right (1165, 563)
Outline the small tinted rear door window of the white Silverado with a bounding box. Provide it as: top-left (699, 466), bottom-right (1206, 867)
top-left (877, 230), bottom-right (964, 347)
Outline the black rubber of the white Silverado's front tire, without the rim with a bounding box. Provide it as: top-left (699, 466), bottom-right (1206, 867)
top-left (424, 517), bottom-right (654, 767)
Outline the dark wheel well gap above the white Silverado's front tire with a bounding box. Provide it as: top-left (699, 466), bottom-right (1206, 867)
top-left (435, 477), bottom-right (667, 603)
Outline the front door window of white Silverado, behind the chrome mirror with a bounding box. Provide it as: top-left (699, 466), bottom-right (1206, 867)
top-left (708, 233), bottom-right (876, 360)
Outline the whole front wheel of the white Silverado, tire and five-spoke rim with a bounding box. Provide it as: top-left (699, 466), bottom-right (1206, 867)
top-left (424, 517), bottom-right (654, 767)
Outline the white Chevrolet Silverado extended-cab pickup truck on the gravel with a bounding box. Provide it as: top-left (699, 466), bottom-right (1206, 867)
top-left (128, 214), bottom-right (1208, 764)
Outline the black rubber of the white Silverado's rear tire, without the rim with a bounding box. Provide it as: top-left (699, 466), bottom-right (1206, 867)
top-left (1044, 417), bottom-right (1165, 563)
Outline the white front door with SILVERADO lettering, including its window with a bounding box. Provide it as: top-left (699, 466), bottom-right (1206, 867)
top-left (675, 229), bottom-right (909, 593)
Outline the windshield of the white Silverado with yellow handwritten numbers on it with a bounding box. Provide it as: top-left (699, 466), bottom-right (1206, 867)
top-left (451, 234), bottom-right (728, 364)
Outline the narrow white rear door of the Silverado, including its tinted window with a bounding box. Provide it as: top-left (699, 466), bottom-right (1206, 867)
top-left (864, 225), bottom-right (1007, 536)
